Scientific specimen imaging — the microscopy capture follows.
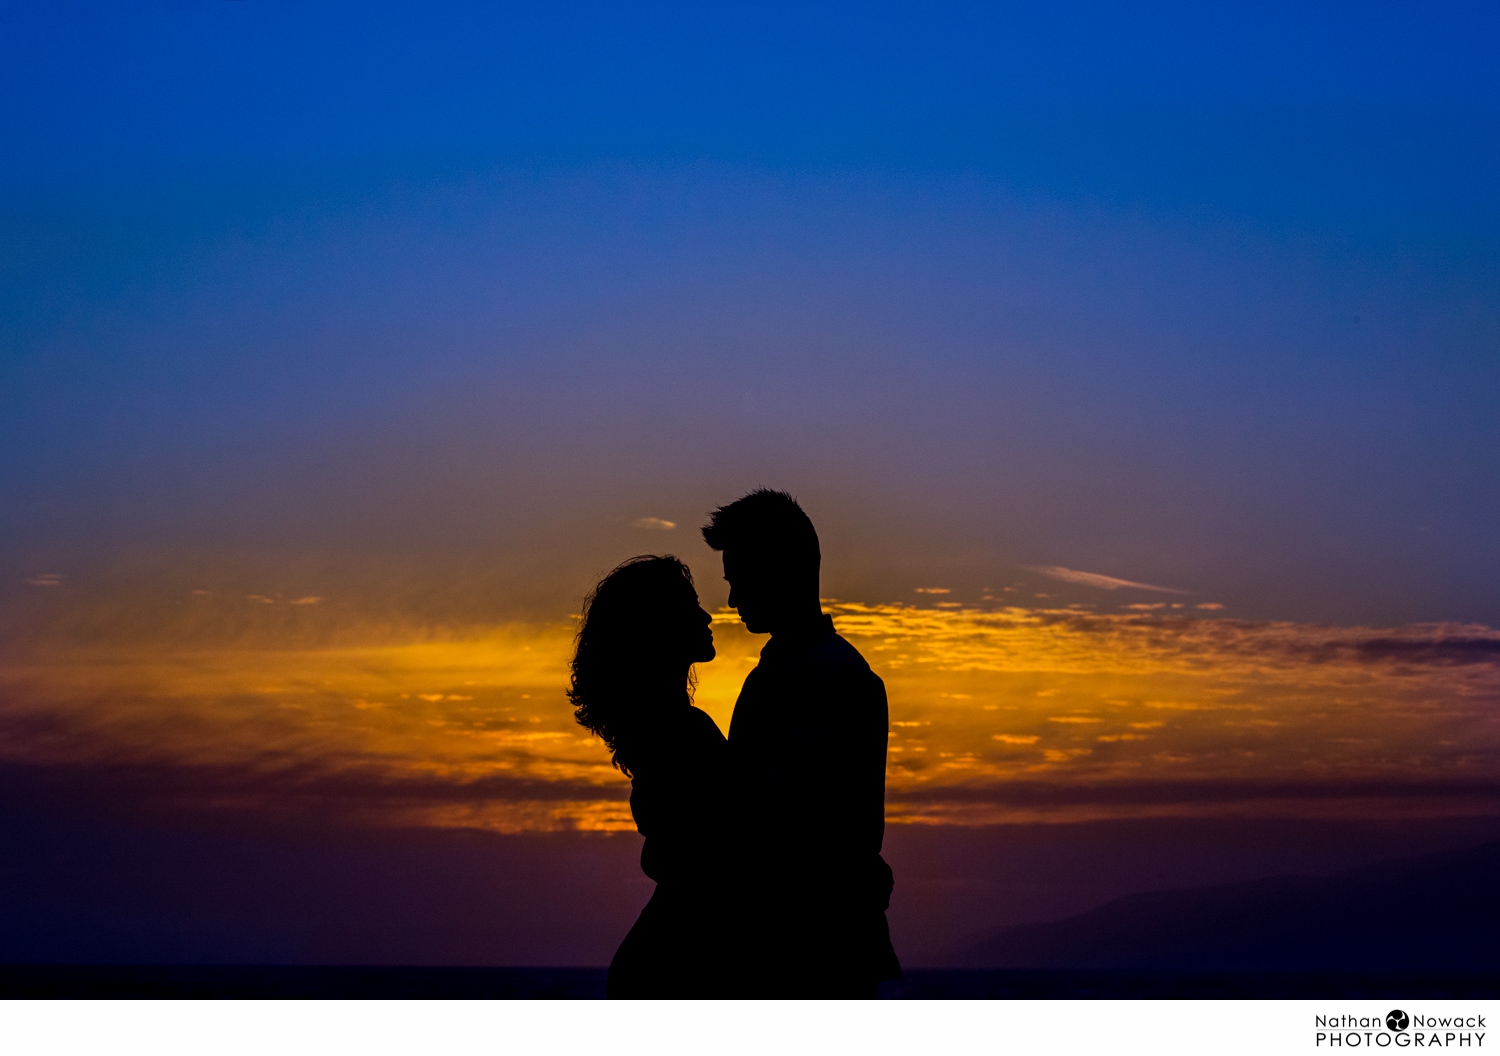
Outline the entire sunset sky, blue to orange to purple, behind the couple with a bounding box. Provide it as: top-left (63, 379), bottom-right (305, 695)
top-left (0, 0), bottom-right (1500, 963)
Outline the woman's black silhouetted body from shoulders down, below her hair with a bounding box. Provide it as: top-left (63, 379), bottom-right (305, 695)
top-left (608, 705), bottom-right (737, 998)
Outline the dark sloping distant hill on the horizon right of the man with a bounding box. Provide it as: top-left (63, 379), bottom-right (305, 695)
top-left (954, 843), bottom-right (1500, 972)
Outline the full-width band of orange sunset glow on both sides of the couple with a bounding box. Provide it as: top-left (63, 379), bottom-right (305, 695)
top-left (0, 602), bottom-right (1500, 833)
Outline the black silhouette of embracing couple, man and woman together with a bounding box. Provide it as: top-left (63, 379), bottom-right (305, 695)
top-left (569, 489), bottom-right (900, 998)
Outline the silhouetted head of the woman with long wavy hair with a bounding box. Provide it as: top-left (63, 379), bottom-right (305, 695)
top-left (569, 557), bottom-right (714, 774)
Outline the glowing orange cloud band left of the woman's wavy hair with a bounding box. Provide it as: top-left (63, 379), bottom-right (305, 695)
top-left (0, 618), bottom-right (621, 831)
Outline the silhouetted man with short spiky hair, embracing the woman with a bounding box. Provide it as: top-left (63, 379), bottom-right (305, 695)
top-left (704, 489), bottom-right (900, 998)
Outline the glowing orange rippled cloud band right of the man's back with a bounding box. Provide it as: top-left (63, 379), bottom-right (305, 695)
top-left (828, 603), bottom-right (1500, 825)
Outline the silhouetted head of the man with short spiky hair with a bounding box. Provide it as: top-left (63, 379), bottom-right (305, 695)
top-left (704, 488), bottom-right (822, 635)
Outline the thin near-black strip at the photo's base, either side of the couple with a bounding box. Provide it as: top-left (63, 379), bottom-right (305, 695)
top-left (0, 965), bottom-right (1500, 1001)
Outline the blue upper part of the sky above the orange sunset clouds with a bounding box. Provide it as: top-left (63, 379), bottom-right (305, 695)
top-left (0, 0), bottom-right (1500, 623)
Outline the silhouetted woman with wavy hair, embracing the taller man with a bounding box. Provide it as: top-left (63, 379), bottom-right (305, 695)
top-left (569, 557), bottom-right (729, 998)
